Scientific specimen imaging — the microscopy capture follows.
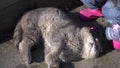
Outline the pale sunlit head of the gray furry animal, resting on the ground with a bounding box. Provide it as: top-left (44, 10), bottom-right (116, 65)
top-left (81, 27), bottom-right (102, 59)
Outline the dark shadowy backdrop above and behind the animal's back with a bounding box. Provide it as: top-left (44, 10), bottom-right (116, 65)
top-left (0, 0), bottom-right (82, 42)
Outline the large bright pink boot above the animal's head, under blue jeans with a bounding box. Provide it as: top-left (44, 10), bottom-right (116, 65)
top-left (80, 8), bottom-right (103, 21)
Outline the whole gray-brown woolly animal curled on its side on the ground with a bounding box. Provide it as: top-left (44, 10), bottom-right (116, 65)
top-left (13, 7), bottom-right (101, 68)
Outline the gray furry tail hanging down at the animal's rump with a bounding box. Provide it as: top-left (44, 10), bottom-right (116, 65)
top-left (13, 23), bottom-right (23, 48)
